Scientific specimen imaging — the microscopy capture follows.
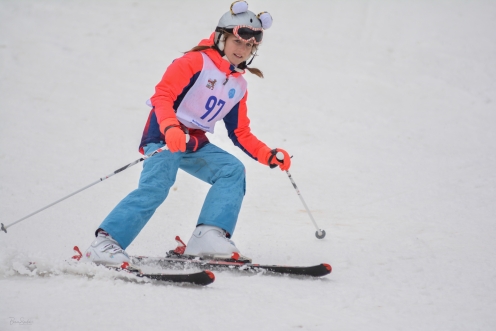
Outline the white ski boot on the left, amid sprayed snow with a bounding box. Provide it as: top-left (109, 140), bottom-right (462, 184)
top-left (80, 231), bottom-right (130, 267)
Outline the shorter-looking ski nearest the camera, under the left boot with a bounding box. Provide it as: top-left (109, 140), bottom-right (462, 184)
top-left (72, 246), bottom-right (215, 286)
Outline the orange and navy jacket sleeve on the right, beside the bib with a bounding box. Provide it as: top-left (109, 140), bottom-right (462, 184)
top-left (224, 91), bottom-right (269, 160)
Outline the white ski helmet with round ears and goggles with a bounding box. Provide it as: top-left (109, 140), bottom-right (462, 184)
top-left (214, 1), bottom-right (272, 55)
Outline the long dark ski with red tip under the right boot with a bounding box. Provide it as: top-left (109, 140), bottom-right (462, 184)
top-left (131, 255), bottom-right (332, 277)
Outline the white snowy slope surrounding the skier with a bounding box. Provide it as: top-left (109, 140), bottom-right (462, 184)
top-left (0, 0), bottom-right (496, 330)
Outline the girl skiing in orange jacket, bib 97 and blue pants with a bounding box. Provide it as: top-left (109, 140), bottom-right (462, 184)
top-left (82, 1), bottom-right (291, 265)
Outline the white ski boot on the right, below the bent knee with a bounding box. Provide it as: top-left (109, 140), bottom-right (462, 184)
top-left (184, 225), bottom-right (251, 262)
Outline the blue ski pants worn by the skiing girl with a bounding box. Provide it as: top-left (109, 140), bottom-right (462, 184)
top-left (100, 143), bottom-right (246, 249)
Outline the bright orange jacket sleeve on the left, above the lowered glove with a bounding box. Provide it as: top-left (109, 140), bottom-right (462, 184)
top-left (150, 52), bottom-right (203, 124)
